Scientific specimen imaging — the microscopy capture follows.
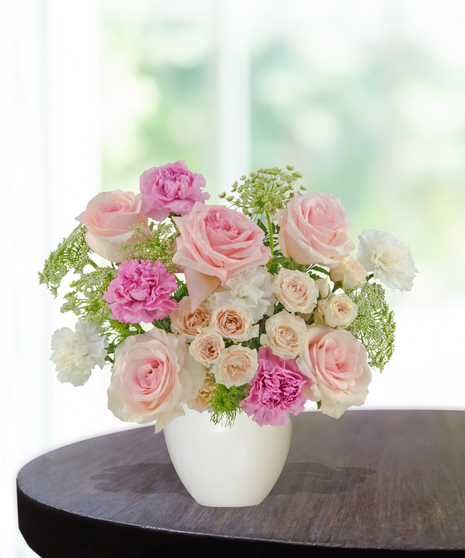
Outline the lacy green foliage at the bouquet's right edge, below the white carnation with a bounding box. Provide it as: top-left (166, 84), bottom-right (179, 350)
top-left (346, 283), bottom-right (396, 372)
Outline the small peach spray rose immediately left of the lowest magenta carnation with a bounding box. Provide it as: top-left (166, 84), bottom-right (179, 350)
top-left (211, 345), bottom-right (258, 388)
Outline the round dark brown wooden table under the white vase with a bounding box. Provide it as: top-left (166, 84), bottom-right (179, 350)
top-left (18, 410), bottom-right (465, 558)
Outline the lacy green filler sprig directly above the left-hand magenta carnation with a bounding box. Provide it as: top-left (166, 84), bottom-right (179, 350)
top-left (120, 223), bottom-right (177, 273)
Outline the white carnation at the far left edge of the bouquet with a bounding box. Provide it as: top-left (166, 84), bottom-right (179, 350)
top-left (50, 320), bottom-right (108, 386)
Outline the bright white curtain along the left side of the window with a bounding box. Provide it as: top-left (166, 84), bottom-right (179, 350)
top-left (0, 0), bottom-right (99, 558)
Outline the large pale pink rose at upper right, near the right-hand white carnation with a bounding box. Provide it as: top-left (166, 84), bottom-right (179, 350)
top-left (275, 193), bottom-right (355, 268)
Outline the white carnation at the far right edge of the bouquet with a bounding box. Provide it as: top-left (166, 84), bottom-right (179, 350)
top-left (357, 229), bottom-right (418, 291)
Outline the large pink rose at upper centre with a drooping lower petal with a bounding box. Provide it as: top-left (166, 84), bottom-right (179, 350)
top-left (173, 203), bottom-right (271, 309)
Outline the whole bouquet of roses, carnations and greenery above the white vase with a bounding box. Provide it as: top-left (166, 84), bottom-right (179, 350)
top-left (39, 161), bottom-right (417, 431)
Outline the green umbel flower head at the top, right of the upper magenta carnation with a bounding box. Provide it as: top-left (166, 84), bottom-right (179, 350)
top-left (219, 165), bottom-right (304, 220)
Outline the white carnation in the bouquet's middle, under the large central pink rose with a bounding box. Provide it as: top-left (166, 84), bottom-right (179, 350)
top-left (208, 267), bottom-right (276, 323)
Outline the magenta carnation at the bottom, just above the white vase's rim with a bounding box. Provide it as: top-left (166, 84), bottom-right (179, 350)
top-left (241, 347), bottom-right (310, 426)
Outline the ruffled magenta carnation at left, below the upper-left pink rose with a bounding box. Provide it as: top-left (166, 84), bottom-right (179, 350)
top-left (103, 260), bottom-right (178, 324)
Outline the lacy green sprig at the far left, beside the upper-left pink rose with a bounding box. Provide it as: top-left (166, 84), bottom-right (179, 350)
top-left (39, 224), bottom-right (96, 297)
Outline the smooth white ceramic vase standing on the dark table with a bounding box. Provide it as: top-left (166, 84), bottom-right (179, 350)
top-left (164, 408), bottom-right (292, 507)
